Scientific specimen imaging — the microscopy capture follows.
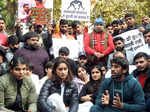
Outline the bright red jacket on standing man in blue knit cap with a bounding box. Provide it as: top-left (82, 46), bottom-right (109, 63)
top-left (84, 32), bottom-right (114, 56)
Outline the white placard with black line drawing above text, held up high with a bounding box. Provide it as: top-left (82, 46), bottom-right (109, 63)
top-left (61, 0), bottom-right (91, 21)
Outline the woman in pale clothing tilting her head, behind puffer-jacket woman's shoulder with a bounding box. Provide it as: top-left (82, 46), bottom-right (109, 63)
top-left (73, 65), bottom-right (89, 93)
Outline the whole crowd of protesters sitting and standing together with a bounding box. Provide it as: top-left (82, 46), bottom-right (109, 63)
top-left (0, 14), bottom-right (150, 112)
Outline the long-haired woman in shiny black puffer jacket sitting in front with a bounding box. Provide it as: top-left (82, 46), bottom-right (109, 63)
top-left (38, 58), bottom-right (78, 112)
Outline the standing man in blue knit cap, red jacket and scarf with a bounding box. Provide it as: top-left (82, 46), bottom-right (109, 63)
top-left (84, 18), bottom-right (114, 64)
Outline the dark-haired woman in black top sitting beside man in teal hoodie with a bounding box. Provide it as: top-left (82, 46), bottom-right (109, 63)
top-left (78, 65), bottom-right (103, 112)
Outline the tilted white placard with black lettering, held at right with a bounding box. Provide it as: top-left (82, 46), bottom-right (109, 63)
top-left (115, 29), bottom-right (145, 53)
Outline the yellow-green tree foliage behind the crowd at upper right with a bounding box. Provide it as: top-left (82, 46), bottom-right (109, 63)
top-left (91, 0), bottom-right (150, 23)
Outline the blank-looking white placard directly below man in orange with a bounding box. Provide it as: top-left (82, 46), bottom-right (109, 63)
top-left (52, 38), bottom-right (80, 60)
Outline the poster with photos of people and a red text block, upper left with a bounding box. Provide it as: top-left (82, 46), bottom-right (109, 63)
top-left (18, 0), bottom-right (53, 24)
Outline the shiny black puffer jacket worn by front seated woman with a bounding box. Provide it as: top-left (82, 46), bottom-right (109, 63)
top-left (38, 79), bottom-right (79, 112)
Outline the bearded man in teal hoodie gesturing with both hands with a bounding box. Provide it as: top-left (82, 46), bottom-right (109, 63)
top-left (90, 57), bottom-right (145, 112)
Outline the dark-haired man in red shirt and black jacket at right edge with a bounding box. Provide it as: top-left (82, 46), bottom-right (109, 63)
top-left (132, 52), bottom-right (150, 112)
